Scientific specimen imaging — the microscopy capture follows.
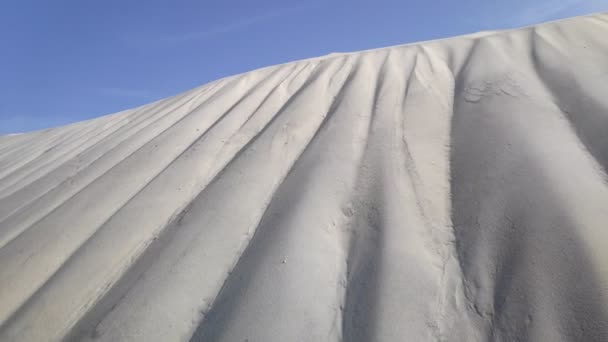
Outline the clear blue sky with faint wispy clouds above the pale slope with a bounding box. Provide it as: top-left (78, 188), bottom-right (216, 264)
top-left (0, 0), bottom-right (608, 134)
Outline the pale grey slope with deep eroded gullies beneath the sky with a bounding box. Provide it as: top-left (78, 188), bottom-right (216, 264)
top-left (0, 14), bottom-right (608, 342)
